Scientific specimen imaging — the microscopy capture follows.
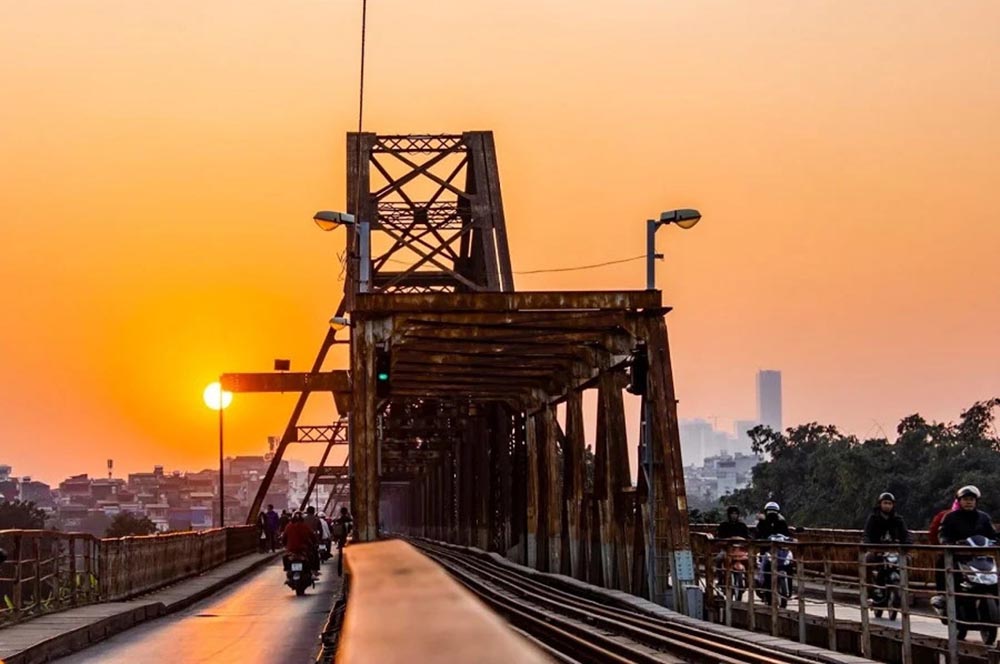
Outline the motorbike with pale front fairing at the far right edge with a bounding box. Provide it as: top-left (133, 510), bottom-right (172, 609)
top-left (935, 535), bottom-right (1000, 645)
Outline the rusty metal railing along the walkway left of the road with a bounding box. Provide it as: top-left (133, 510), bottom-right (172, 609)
top-left (0, 526), bottom-right (257, 627)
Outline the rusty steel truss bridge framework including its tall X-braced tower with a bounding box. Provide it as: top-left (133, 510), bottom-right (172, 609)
top-left (242, 132), bottom-right (690, 608)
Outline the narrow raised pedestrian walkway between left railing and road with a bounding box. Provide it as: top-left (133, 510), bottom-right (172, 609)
top-left (0, 553), bottom-right (277, 664)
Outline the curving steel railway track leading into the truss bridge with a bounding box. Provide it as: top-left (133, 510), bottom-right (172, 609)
top-left (410, 540), bottom-right (836, 664)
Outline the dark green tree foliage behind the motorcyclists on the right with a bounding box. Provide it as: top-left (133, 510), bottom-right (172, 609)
top-left (723, 399), bottom-right (1000, 530)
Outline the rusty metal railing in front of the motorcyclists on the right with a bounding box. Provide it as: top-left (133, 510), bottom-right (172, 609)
top-left (692, 533), bottom-right (1000, 664)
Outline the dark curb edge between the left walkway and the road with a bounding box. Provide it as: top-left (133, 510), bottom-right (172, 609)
top-left (0, 553), bottom-right (280, 664)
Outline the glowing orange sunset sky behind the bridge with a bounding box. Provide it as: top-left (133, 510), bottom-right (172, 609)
top-left (0, 0), bottom-right (1000, 481)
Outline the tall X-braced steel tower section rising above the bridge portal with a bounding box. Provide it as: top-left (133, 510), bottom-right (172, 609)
top-left (345, 132), bottom-right (514, 310)
